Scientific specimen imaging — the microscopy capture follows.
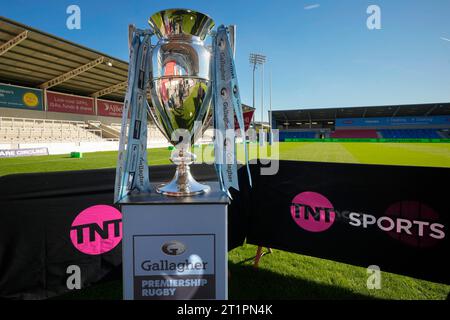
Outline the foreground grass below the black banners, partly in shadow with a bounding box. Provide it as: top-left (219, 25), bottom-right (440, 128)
top-left (56, 244), bottom-right (450, 300)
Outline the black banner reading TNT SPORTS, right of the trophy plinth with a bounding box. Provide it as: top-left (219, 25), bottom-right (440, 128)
top-left (243, 161), bottom-right (450, 284)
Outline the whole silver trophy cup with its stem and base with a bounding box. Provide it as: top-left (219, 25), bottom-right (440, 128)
top-left (148, 9), bottom-right (214, 196)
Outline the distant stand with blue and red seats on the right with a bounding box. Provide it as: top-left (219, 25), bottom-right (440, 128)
top-left (269, 103), bottom-right (450, 142)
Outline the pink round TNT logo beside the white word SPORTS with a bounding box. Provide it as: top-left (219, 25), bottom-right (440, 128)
top-left (291, 191), bottom-right (336, 232)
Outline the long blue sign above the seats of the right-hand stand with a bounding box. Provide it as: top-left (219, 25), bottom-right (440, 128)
top-left (336, 116), bottom-right (450, 129)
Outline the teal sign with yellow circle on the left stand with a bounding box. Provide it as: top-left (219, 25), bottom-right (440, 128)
top-left (0, 84), bottom-right (43, 110)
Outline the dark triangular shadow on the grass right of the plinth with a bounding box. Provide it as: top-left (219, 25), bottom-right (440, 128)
top-left (228, 262), bottom-right (374, 300)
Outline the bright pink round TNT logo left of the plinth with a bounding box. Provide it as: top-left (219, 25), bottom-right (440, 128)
top-left (70, 205), bottom-right (122, 255)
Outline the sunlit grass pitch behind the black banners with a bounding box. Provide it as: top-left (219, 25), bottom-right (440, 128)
top-left (0, 142), bottom-right (450, 176)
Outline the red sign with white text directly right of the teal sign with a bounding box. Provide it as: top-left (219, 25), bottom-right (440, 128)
top-left (47, 91), bottom-right (95, 114)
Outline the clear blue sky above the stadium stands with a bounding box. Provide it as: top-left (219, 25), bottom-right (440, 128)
top-left (0, 0), bottom-right (450, 120)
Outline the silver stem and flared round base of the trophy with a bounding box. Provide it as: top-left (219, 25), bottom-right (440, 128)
top-left (156, 149), bottom-right (211, 197)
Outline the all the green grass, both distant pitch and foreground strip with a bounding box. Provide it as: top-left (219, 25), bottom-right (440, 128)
top-left (0, 142), bottom-right (450, 299)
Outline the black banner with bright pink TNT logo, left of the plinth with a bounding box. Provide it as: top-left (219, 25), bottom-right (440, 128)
top-left (0, 165), bottom-right (245, 299)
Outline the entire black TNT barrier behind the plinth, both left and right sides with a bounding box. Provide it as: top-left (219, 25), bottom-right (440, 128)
top-left (0, 161), bottom-right (450, 299)
